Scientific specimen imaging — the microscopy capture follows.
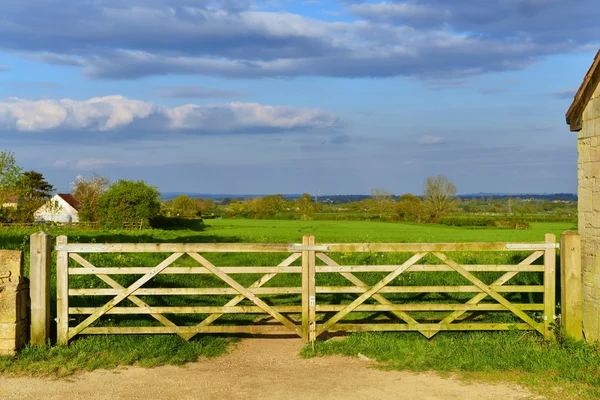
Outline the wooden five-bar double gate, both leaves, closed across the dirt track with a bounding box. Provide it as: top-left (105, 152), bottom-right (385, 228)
top-left (55, 235), bottom-right (558, 344)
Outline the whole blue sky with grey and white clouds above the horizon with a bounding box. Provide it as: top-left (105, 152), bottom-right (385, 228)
top-left (0, 0), bottom-right (600, 194)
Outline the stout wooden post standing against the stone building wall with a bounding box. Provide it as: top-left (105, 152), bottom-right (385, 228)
top-left (560, 231), bottom-right (583, 340)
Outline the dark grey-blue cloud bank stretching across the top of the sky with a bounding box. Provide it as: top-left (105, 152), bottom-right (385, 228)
top-left (0, 0), bottom-right (600, 80)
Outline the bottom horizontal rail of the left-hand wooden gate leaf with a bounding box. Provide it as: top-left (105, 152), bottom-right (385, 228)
top-left (80, 325), bottom-right (300, 335)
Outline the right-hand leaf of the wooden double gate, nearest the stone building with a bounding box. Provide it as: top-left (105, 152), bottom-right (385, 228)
top-left (309, 234), bottom-right (558, 338)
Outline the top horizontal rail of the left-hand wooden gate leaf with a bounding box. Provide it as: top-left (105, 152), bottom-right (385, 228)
top-left (55, 243), bottom-right (291, 253)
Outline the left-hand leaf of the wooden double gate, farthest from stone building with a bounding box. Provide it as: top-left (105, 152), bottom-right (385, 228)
top-left (55, 236), bottom-right (308, 344)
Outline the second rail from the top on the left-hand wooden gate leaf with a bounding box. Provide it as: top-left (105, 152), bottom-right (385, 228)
top-left (69, 266), bottom-right (302, 275)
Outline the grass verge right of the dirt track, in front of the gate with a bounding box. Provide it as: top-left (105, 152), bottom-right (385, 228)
top-left (302, 332), bottom-right (600, 399)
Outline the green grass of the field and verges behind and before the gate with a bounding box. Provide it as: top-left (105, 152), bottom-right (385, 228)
top-left (0, 219), bottom-right (600, 398)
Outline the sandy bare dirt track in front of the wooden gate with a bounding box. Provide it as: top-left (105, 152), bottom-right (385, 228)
top-left (0, 339), bottom-right (532, 400)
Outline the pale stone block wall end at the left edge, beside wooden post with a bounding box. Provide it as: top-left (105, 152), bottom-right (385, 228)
top-left (0, 250), bottom-right (29, 355)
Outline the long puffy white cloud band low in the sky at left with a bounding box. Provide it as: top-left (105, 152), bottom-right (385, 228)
top-left (0, 96), bottom-right (339, 133)
